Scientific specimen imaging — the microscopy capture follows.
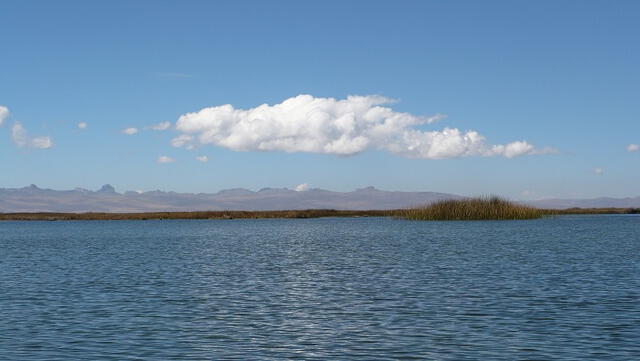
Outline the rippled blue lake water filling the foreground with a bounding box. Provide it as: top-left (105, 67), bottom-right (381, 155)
top-left (0, 216), bottom-right (640, 360)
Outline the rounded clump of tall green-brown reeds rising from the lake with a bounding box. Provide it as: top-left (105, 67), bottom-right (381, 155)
top-left (402, 196), bottom-right (547, 221)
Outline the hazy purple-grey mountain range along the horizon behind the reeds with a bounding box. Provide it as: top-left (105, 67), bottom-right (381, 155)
top-left (0, 184), bottom-right (640, 213)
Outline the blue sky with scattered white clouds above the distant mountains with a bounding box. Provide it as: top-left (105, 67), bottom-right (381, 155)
top-left (0, 0), bottom-right (640, 199)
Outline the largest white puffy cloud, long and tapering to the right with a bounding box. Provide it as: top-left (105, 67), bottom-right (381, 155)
top-left (172, 95), bottom-right (552, 159)
